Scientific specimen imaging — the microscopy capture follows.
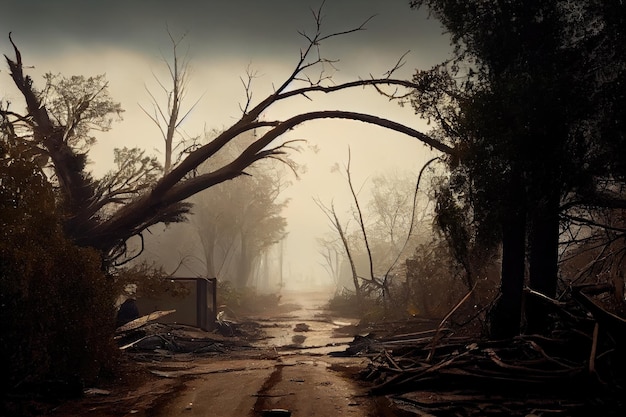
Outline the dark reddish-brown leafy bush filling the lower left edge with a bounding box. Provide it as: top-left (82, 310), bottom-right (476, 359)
top-left (0, 136), bottom-right (117, 395)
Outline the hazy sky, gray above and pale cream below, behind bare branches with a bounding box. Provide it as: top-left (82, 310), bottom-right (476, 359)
top-left (0, 0), bottom-right (450, 286)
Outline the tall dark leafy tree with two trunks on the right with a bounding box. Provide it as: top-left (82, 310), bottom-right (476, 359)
top-left (412, 0), bottom-right (626, 334)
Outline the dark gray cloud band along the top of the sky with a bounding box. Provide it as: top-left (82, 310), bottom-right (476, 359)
top-left (0, 0), bottom-right (447, 62)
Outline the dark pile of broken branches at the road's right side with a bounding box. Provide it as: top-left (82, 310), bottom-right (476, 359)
top-left (338, 286), bottom-right (626, 416)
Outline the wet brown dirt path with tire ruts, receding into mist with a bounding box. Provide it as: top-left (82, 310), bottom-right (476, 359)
top-left (152, 294), bottom-right (386, 417)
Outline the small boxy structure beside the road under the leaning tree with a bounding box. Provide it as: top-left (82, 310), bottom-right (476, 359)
top-left (137, 277), bottom-right (217, 331)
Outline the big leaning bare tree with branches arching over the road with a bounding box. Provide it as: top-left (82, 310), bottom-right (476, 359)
top-left (2, 13), bottom-right (453, 270)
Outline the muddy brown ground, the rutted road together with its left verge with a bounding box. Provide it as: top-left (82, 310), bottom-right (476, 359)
top-left (52, 293), bottom-right (395, 417)
